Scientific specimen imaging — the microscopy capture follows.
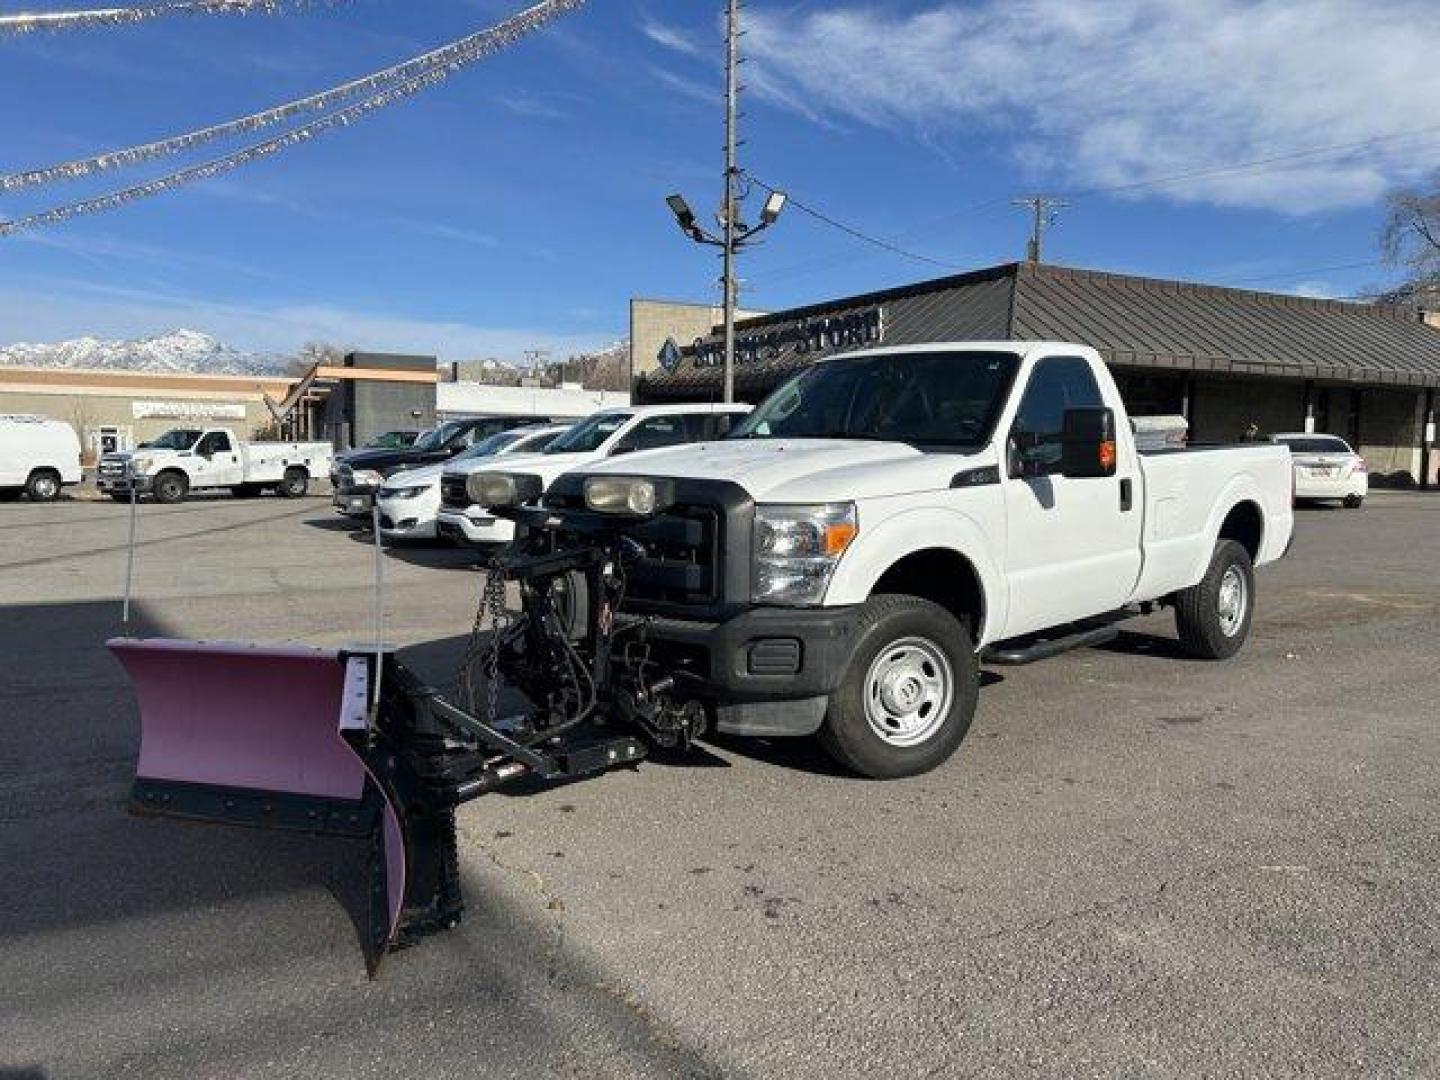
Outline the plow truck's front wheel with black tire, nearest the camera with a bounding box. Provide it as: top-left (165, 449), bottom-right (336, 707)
top-left (819, 595), bottom-right (979, 779)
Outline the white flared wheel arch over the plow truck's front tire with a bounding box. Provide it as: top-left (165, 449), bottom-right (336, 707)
top-left (825, 507), bottom-right (1007, 648)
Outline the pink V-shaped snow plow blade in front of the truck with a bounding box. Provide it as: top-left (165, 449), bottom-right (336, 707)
top-left (107, 638), bottom-right (406, 972)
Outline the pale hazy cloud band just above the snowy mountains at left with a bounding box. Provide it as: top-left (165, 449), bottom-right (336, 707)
top-left (0, 279), bottom-right (616, 360)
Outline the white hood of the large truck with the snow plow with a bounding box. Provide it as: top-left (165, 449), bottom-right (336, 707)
top-left (585, 439), bottom-right (979, 503)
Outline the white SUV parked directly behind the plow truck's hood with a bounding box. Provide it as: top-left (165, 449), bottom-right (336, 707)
top-left (436, 403), bottom-right (750, 544)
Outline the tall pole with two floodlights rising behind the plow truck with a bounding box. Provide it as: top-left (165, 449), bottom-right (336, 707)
top-left (665, 0), bottom-right (785, 402)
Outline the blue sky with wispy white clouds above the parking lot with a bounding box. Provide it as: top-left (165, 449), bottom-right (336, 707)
top-left (0, 0), bottom-right (1440, 359)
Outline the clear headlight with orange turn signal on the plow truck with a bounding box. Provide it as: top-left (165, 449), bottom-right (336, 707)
top-left (750, 503), bottom-right (860, 605)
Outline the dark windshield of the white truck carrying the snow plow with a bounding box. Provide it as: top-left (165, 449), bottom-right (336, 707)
top-left (729, 351), bottom-right (1020, 446)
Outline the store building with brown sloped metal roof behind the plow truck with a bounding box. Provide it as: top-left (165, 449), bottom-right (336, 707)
top-left (634, 262), bottom-right (1440, 482)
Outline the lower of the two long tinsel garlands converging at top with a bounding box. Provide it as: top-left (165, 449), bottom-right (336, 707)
top-left (0, 0), bottom-right (585, 236)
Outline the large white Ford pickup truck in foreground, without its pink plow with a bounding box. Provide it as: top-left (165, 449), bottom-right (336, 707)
top-left (506, 341), bottom-right (1293, 776)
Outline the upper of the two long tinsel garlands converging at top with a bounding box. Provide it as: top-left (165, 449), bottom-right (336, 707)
top-left (0, 0), bottom-right (585, 192)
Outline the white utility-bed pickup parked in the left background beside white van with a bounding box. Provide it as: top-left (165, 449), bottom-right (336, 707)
top-left (96, 428), bottom-right (331, 503)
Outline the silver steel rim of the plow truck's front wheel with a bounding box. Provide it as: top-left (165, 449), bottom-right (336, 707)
top-left (865, 638), bottom-right (955, 746)
